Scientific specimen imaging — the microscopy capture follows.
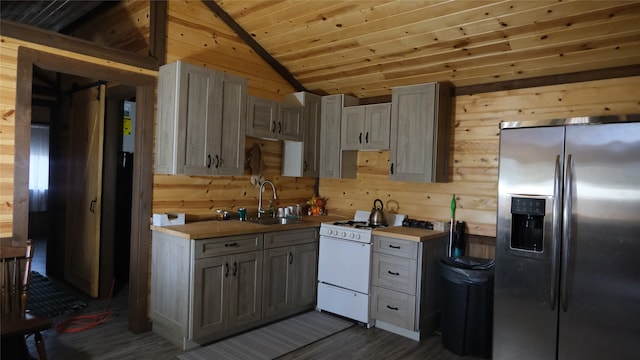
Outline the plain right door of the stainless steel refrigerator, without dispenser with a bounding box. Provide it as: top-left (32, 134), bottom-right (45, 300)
top-left (556, 123), bottom-right (640, 359)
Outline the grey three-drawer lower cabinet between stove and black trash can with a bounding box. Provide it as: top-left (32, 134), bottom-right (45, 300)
top-left (370, 235), bottom-right (447, 341)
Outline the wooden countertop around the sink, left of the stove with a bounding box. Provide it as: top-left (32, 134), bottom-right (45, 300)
top-left (151, 215), bottom-right (348, 240)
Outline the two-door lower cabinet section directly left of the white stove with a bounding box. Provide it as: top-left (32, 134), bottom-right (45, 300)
top-left (262, 229), bottom-right (318, 320)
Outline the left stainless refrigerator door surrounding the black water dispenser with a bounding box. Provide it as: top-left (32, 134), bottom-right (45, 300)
top-left (493, 127), bottom-right (564, 360)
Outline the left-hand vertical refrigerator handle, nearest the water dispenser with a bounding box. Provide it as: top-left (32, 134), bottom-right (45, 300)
top-left (549, 155), bottom-right (562, 311)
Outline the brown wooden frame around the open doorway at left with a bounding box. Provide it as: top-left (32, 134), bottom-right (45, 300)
top-left (13, 47), bottom-right (156, 333)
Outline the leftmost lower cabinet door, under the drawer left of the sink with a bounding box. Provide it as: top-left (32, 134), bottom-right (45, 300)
top-left (189, 256), bottom-right (230, 339)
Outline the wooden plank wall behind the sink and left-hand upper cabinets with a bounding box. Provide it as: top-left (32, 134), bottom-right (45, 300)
top-left (153, 1), bottom-right (317, 219)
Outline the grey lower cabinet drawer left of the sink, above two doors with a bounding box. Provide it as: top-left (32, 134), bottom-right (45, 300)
top-left (195, 234), bottom-right (263, 259)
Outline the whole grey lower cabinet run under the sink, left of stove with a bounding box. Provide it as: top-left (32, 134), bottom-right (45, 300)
top-left (151, 228), bottom-right (318, 350)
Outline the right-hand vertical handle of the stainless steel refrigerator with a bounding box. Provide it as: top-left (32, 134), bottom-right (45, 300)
top-left (560, 154), bottom-right (573, 312)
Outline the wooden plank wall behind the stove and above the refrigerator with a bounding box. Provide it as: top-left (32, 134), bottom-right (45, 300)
top-left (320, 77), bottom-right (640, 257)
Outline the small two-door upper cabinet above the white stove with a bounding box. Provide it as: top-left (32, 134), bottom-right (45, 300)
top-left (341, 103), bottom-right (391, 150)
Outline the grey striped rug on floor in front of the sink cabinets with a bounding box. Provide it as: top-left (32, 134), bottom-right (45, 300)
top-left (178, 311), bottom-right (354, 360)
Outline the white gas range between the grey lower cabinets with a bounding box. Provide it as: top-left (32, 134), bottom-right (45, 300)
top-left (317, 210), bottom-right (406, 328)
